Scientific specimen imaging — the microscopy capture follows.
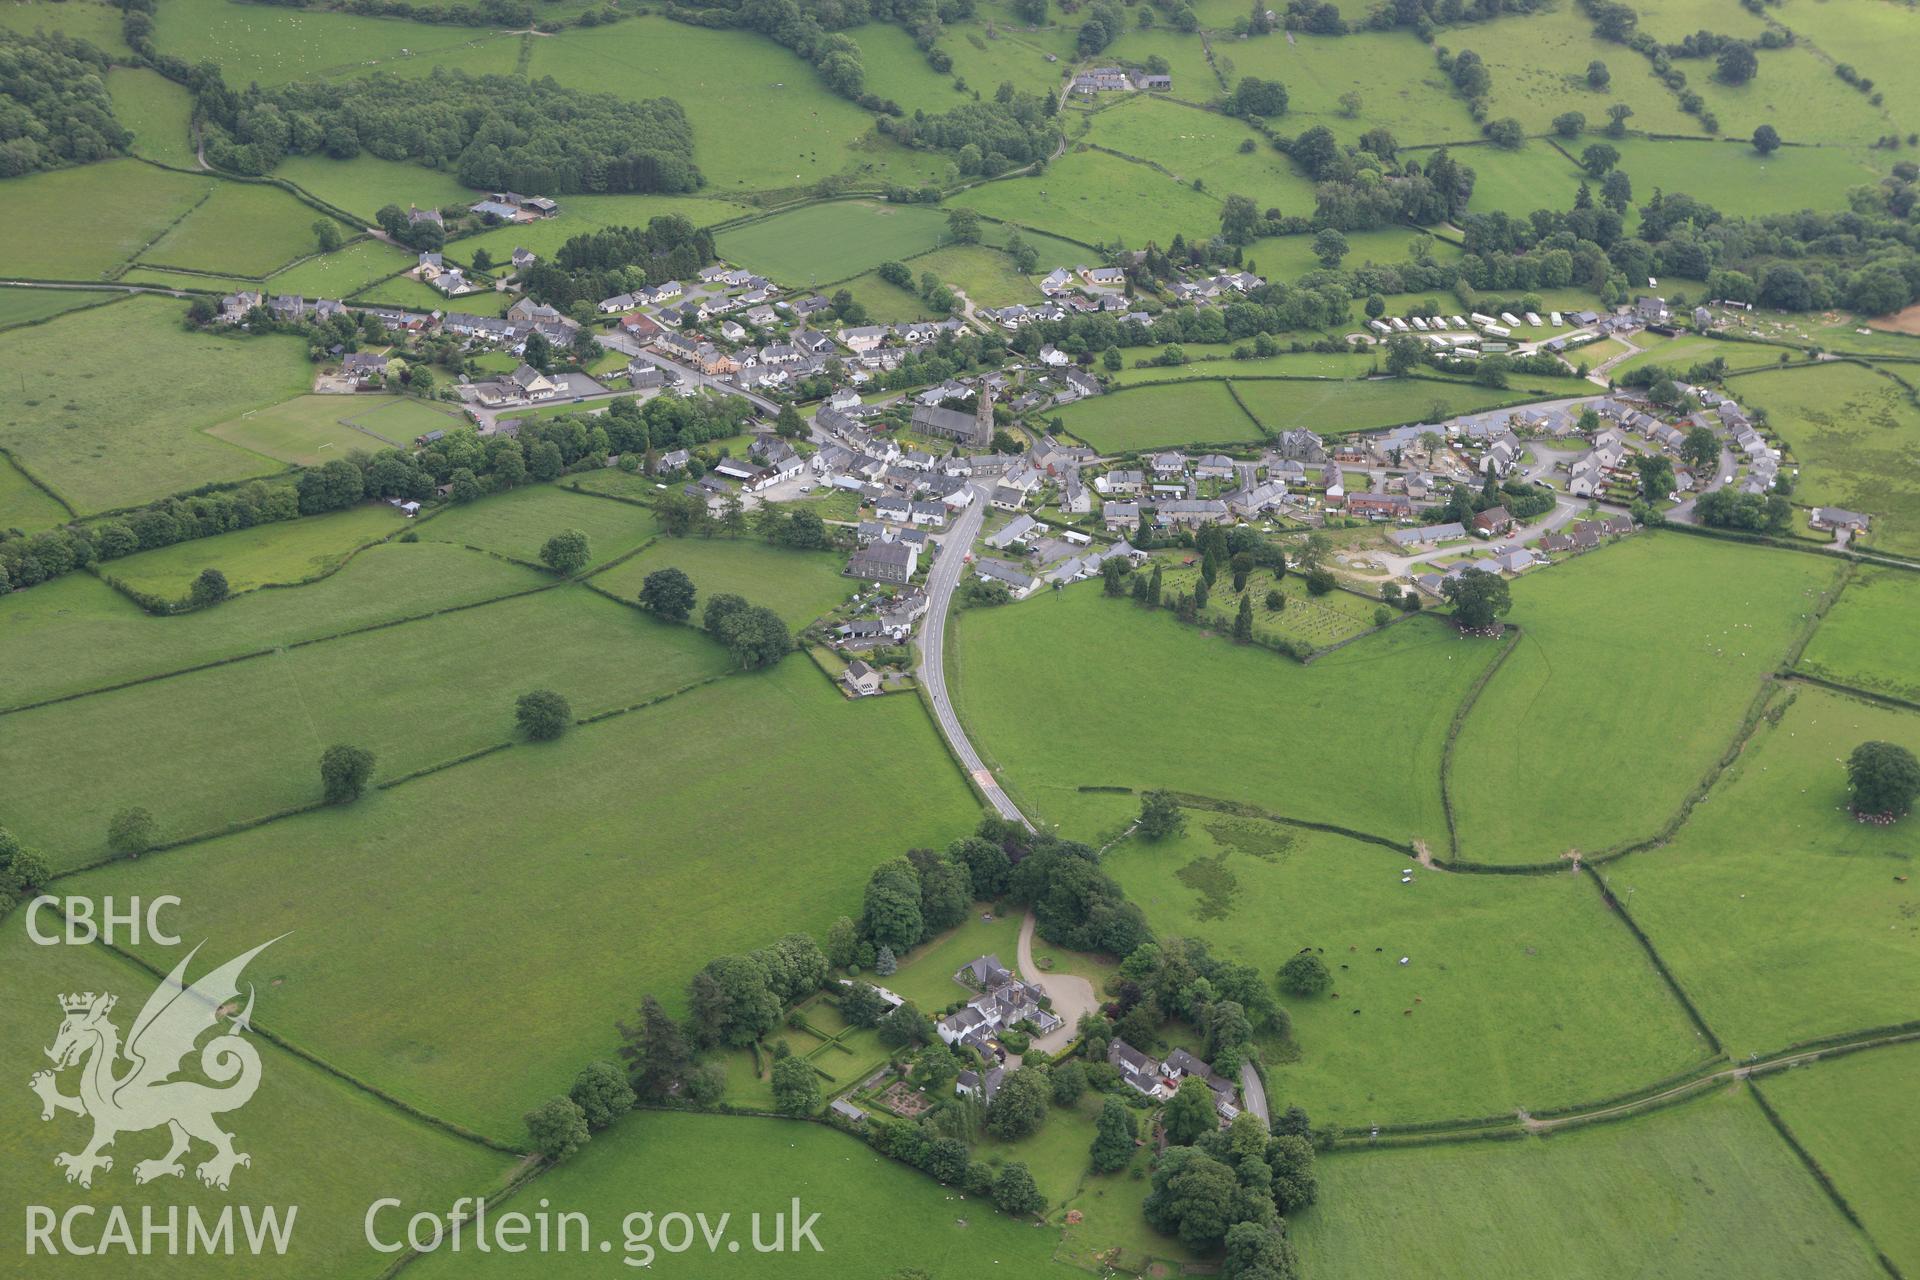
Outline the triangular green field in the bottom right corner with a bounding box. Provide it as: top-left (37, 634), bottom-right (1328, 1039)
top-left (1761, 1044), bottom-right (1920, 1270)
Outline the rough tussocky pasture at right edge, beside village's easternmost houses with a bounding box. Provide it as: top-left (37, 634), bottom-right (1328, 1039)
top-left (1726, 365), bottom-right (1920, 557)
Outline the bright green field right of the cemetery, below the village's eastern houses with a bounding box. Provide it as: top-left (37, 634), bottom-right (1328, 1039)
top-left (1452, 533), bottom-right (1836, 864)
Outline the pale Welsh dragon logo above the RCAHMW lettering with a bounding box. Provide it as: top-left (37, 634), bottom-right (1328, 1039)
top-left (29, 938), bottom-right (278, 1192)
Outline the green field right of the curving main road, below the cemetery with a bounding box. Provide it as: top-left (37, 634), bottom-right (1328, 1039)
top-left (948, 585), bottom-right (1496, 841)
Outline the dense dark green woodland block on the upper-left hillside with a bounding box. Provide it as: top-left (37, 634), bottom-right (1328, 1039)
top-left (192, 63), bottom-right (705, 196)
